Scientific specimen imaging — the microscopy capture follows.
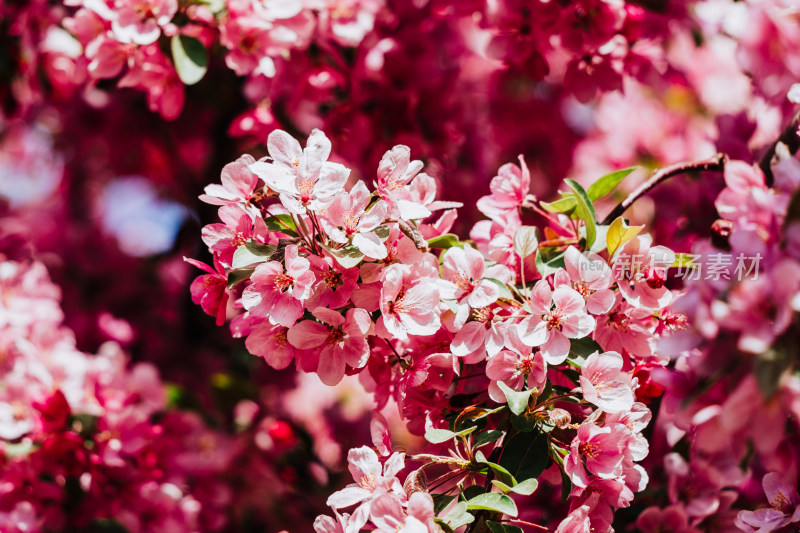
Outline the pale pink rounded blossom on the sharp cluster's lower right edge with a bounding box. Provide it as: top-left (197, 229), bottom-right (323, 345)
top-left (580, 352), bottom-right (634, 413)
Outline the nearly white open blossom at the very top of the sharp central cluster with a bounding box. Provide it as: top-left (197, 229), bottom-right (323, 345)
top-left (250, 129), bottom-right (350, 214)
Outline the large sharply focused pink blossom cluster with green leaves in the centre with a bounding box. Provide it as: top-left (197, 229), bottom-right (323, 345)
top-left (188, 130), bottom-right (683, 531)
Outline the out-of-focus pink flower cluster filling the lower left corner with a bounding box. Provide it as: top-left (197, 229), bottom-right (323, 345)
top-left (0, 259), bottom-right (238, 532)
